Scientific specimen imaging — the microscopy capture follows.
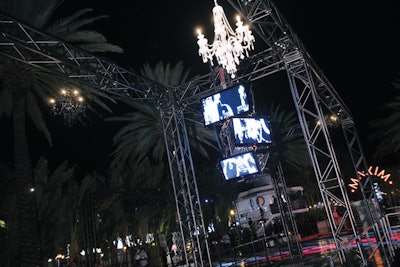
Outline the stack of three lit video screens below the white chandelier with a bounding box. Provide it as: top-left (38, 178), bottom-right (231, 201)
top-left (201, 84), bottom-right (271, 180)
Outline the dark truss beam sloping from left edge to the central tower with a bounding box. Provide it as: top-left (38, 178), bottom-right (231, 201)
top-left (0, 13), bottom-right (163, 98)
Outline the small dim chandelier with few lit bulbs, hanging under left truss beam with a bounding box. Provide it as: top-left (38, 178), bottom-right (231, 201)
top-left (50, 89), bottom-right (86, 127)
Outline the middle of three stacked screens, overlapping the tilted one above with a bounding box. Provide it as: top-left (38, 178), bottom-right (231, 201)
top-left (231, 117), bottom-right (272, 146)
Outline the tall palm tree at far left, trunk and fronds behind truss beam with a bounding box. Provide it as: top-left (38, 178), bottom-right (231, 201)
top-left (0, 0), bottom-right (122, 266)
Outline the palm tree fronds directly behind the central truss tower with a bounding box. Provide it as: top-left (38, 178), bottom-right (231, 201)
top-left (106, 61), bottom-right (217, 173)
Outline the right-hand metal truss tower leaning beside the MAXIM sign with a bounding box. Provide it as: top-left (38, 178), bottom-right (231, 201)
top-left (225, 0), bottom-right (393, 266)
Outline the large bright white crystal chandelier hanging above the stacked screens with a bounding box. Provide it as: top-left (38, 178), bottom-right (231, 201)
top-left (197, 0), bottom-right (254, 78)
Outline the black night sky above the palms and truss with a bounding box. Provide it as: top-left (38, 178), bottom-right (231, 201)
top-left (2, 0), bottom-right (400, 173)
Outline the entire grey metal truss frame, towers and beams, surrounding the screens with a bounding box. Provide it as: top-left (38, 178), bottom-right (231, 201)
top-left (0, 0), bottom-right (394, 266)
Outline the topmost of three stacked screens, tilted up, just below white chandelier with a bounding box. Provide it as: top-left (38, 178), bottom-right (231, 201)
top-left (201, 84), bottom-right (250, 126)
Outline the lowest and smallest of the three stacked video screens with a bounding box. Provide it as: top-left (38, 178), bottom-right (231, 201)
top-left (219, 151), bottom-right (260, 180)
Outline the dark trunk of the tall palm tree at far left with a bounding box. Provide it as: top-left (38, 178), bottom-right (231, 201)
top-left (12, 81), bottom-right (41, 267)
